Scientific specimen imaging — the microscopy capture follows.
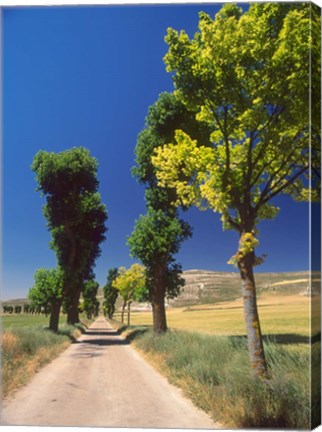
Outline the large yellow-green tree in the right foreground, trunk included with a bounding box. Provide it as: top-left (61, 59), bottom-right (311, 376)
top-left (152, 3), bottom-right (320, 376)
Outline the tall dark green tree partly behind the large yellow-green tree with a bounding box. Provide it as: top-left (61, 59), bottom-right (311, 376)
top-left (128, 93), bottom-right (209, 332)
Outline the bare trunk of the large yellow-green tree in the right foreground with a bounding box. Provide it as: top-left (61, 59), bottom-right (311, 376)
top-left (238, 252), bottom-right (267, 377)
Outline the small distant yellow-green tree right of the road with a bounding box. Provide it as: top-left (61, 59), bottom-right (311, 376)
top-left (112, 264), bottom-right (147, 322)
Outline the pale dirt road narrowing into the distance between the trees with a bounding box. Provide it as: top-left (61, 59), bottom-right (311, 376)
top-left (1, 318), bottom-right (218, 429)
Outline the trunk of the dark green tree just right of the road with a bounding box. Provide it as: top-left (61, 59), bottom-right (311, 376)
top-left (151, 264), bottom-right (168, 333)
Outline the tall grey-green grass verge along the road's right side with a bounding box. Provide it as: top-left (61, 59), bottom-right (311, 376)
top-left (134, 330), bottom-right (311, 429)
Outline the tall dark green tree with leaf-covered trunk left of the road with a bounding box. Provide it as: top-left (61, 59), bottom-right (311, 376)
top-left (32, 147), bottom-right (107, 324)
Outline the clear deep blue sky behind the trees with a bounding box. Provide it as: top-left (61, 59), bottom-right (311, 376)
top-left (2, 4), bottom-right (308, 298)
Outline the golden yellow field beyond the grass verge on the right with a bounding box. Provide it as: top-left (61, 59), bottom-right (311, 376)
top-left (131, 294), bottom-right (312, 342)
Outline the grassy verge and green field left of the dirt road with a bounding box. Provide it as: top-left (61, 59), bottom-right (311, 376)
top-left (1, 315), bottom-right (89, 397)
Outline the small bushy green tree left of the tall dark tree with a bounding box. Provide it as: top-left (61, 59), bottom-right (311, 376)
top-left (28, 268), bottom-right (63, 332)
